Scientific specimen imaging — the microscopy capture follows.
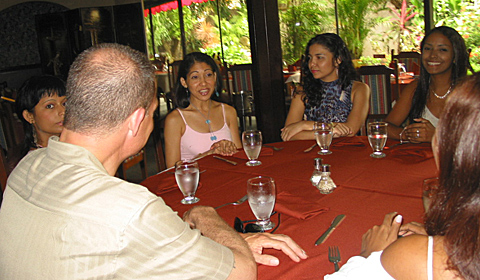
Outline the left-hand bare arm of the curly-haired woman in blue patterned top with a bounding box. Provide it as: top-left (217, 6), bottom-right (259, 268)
top-left (282, 94), bottom-right (315, 141)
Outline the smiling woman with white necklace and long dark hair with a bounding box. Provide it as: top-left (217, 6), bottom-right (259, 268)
top-left (385, 26), bottom-right (473, 143)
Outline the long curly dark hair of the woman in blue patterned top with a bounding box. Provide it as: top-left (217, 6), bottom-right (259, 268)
top-left (302, 33), bottom-right (359, 107)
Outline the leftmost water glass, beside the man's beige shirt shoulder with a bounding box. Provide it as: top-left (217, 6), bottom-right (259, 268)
top-left (175, 160), bottom-right (200, 204)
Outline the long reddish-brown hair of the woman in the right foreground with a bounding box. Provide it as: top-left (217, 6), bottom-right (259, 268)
top-left (425, 74), bottom-right (480, 279)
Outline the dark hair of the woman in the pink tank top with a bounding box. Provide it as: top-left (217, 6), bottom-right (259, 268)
top-left (173, 52), bottom-right (222, 109)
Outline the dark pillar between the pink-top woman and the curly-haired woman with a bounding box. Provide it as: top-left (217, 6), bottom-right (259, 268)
top-left (247, 0), bottom-right (286, 143)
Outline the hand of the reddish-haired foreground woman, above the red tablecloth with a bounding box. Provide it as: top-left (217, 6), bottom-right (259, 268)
top-left (360, 212), bottom-right (402, 258)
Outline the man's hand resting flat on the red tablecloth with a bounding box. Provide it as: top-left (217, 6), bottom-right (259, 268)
top-left (240, 233), bottom-right (308, 266)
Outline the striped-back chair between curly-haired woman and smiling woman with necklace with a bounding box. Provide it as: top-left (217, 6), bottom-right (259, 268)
top-left (357, 65), bottom-right (398, 136)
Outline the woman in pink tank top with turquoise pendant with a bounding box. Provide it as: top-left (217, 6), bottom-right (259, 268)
top-left (165, 52), bottom-right (242, 167)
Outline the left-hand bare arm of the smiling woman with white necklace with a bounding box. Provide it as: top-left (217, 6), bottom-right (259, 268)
top-left (385, 80), bottom-right (418, 140)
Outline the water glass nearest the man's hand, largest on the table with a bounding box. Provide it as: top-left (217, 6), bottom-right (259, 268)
top-left (247, 176), bottom-right (275, 231)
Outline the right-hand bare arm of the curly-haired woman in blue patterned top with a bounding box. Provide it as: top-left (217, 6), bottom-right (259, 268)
top-left (337, 81), bottom-right (370, 137)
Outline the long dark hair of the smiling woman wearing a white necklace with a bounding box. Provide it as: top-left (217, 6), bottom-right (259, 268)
top-left (408, 26), bottom-right (474, 122)
